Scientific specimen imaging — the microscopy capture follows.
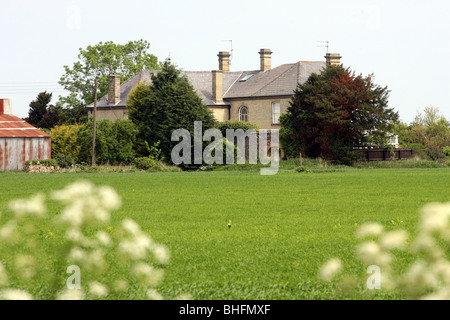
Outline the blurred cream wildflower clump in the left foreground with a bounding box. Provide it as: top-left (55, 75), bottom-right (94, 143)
top-left (0, 181), bottom-right (169, 300)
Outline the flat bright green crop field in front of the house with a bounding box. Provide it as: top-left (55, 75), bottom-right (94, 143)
top-left (0, 168), bottom-right (450, 300)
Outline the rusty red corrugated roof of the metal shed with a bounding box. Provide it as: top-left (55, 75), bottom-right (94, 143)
top-left (0, 114), bottom-right (50, 138)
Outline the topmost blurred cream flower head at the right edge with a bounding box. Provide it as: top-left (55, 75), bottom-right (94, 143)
top-left (420, 203), bottom-right (450, 232)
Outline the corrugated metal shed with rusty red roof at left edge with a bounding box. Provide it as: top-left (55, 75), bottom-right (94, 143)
top-left (0, 98), bottom-right (52, 171)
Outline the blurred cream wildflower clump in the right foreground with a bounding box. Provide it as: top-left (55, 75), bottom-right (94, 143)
top-left (319, 202), bottom-right (450, 300)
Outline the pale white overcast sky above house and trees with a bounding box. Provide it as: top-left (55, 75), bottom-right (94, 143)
top-left (0, 0), bottom-right (450, 123)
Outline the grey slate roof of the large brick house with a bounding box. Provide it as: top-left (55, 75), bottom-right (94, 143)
top-left (88, 61), bottom-right (325, 108)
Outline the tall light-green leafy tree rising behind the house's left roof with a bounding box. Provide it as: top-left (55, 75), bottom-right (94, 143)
top-left (58, 40), bottom-right (160, 106)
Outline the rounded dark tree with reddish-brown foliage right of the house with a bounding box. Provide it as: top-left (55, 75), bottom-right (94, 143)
top-left (280, 65), bottom-right (398, 163)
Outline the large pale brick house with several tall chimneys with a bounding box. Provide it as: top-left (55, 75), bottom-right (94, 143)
top-left (87, 49), bottom-right (341, 129)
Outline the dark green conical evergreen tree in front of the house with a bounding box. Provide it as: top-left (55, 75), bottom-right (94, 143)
top-left (127, 60), bottom-right (215, 161)
